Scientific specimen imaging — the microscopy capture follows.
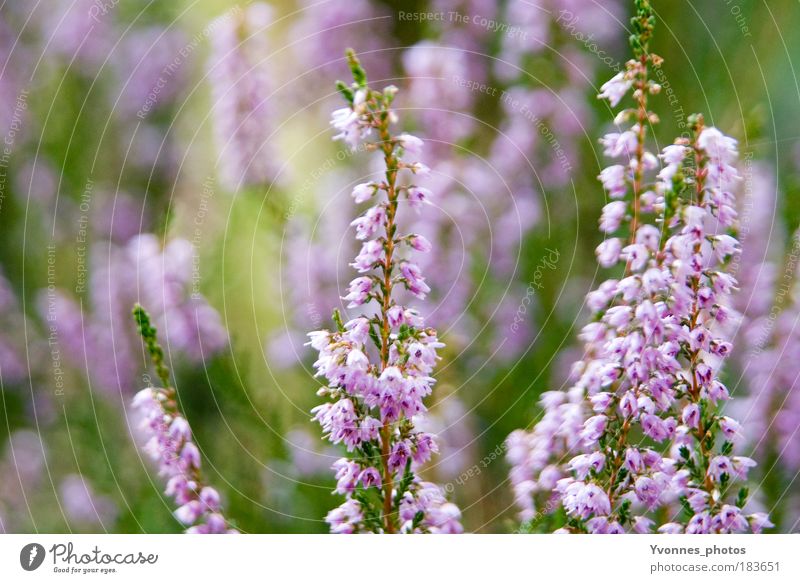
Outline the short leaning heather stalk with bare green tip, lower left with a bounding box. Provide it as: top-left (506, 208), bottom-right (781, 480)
top-left (133, 304), bottom-right (237, 534)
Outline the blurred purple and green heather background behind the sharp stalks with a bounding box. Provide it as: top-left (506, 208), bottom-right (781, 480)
top-left (0, 0), bottom-right (800, 533)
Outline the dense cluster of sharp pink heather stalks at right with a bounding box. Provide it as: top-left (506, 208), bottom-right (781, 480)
top-left (509, 0), bottom-right (771, 533)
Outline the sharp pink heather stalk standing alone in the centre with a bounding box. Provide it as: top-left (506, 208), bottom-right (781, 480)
top-left (309, 51), bottom-right (461, 533)
